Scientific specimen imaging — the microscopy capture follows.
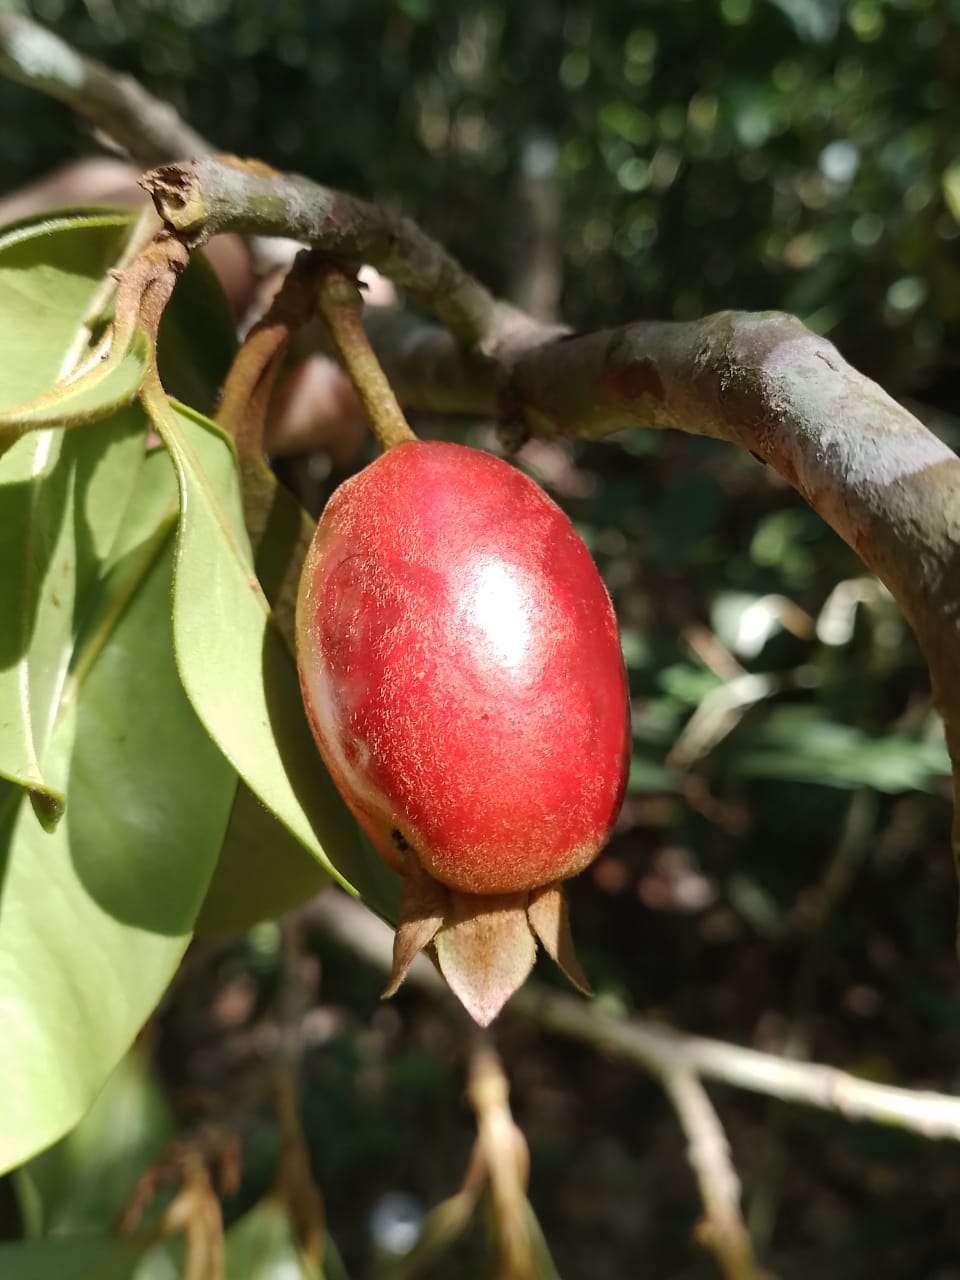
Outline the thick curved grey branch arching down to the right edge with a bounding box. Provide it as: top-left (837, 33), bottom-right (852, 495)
top-left (512, 312), bottom-right (960, 829)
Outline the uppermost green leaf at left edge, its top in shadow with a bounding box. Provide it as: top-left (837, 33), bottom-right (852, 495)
top-left (0, 210), bottom-right (136, 410)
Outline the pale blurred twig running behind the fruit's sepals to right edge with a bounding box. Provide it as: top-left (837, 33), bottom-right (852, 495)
top-left (308, 890), bottom-right (960, 1142)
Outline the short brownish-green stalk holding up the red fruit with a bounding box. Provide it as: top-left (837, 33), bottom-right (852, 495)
top-left (317, 266), bottom-right (416, 452)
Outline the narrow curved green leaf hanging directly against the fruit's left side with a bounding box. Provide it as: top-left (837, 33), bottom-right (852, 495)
top-left (148, 390), bottom-right (398, 919)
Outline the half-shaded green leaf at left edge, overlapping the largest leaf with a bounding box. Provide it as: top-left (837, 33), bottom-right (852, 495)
top-left (0, 406), bottom-right (146, 826)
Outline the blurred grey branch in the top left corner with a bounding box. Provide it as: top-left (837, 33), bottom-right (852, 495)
top-left (0, 14), bottom-right (210, 165)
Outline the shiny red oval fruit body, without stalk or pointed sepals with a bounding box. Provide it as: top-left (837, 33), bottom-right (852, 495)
top-left (297, 442), bottom-right (630, 896)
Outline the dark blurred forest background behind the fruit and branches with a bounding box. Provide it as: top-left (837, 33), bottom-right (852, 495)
top-left (0, 0), bottom-right (960, 1280)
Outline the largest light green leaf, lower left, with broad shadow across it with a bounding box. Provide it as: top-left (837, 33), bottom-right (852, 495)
top-left (0, 453), bottom-right (236, 1170)
